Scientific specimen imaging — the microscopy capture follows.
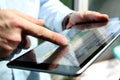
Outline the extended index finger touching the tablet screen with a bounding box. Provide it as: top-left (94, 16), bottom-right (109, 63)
top-left (18, 20), bottom-right (67, 46)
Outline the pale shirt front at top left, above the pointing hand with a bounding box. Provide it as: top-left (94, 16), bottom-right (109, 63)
top-left (0, 0), bottom-right (40, 18)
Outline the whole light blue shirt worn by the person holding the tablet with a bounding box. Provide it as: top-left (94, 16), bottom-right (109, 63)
top-left (0, 0), bottom-right (73, 80)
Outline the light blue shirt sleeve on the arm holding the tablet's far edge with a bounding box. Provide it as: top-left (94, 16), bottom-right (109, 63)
top-left (39, 0), bottom-right (73, 32)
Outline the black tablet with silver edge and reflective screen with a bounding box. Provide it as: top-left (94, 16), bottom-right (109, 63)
top-left (7, 18), bottom-right (120, 76)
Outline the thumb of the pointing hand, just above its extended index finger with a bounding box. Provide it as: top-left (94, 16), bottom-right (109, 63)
top-left (14, 10), bottom-right (45, 26)
